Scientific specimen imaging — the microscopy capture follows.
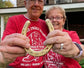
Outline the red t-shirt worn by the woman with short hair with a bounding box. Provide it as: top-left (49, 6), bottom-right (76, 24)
top-left (43, 29), bottom-right (81, 68)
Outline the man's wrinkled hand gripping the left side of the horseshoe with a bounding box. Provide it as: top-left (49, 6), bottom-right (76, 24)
top-left (0, 33), bottom-right (30, 64)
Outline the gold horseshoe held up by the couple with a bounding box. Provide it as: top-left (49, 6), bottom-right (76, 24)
top-left (22, 19), bottom-right (54, 56)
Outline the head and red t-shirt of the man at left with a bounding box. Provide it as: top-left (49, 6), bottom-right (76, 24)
top-left (2, 0), bottom-right (48, 68)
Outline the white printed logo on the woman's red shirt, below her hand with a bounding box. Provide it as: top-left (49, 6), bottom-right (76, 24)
top-left (43, 50), bottom-right (63, 68)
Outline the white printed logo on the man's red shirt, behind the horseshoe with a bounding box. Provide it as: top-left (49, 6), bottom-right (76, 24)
top-left (20, 27), bottom-right (46, 66)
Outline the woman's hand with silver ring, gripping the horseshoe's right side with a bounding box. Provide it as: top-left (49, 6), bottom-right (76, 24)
top-left (44, 30), bottom-right (79, 57)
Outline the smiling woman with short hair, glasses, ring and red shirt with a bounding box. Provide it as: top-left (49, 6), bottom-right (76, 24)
top-left (44, 6), bottom-right (84, 68)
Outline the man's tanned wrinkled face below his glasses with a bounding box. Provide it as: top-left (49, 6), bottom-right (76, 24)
top-left (24, 0), bottom-right (44, 20)
